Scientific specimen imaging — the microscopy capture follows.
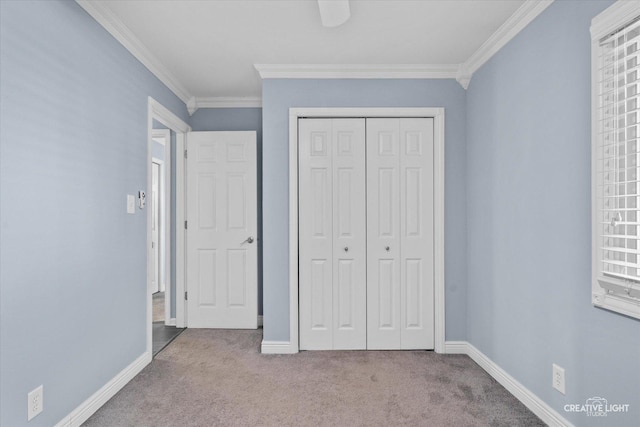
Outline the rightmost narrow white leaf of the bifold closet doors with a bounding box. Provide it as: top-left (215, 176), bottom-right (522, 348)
top-left (400, 119), bottom-right (434, 349)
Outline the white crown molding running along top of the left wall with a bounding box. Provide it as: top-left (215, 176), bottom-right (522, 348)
top-left (76, 0), bottom-right (191, 104)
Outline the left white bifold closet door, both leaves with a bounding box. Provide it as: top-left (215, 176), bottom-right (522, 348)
top-left (298, 119), bottom-right (367, 350)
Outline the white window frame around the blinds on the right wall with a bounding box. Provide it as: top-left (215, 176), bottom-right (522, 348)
top-left (591, 0), bottom-right (640, 319)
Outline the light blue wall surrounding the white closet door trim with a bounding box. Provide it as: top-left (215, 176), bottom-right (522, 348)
top-left (262, 79), bottom-right (467, 341)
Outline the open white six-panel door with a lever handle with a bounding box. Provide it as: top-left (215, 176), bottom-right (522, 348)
top-left (186, 132), bottom-right (258, 329)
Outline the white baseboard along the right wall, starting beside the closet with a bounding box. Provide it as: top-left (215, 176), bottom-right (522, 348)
top-left (445, 341), bottom-right (573, 427)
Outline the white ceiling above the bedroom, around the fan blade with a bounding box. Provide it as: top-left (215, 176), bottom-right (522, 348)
top-left (77, 0), bottom-right (549, 110)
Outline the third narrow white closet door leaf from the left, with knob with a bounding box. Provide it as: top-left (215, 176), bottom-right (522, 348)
top-left (367, 119), bottom-right (401, 350)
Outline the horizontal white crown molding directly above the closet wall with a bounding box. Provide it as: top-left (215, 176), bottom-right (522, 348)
top-left (254, 64), bottom-right (458, 79)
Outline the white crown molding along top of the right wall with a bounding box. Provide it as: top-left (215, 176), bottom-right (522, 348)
top-left (456, 0), bottom-right (554, 89)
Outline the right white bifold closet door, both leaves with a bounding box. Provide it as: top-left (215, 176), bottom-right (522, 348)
top-left (367, 118), bottom-right (434, 349)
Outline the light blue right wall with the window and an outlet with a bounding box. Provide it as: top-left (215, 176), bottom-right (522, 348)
top-left (467, 1), bottom-right (640, 426)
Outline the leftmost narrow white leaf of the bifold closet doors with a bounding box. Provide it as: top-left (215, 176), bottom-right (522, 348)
top-left (298, 119), bottom-right (333, 350)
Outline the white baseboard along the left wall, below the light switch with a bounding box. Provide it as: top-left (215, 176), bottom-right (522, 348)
top-left (55, 352), bottom-right (152, 427)
